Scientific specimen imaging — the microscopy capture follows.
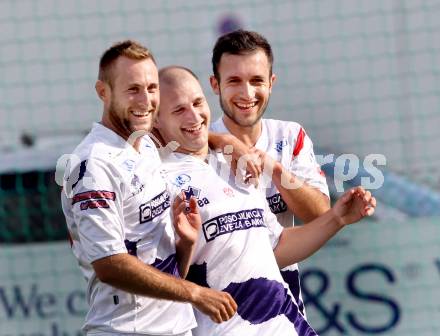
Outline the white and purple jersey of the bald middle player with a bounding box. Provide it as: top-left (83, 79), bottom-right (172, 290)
top-left (162, 153), bottom-right (316, 336)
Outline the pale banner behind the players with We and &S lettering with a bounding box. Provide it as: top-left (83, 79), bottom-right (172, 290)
top-left (0, 219), bottom-right (440, 336)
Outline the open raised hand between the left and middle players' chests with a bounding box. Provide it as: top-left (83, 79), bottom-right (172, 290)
top-left (172, 192), bottom-right (202, 245)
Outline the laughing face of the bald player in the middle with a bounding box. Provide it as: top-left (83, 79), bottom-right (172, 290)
top-left (156, 70), bottom-right (211, 155)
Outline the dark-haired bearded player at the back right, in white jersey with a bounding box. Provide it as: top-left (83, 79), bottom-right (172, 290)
top-left (210, 30), bottom-right (330, 314)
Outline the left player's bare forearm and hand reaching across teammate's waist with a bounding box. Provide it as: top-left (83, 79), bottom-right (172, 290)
top-left (92, 253), bottom-right (237, 323)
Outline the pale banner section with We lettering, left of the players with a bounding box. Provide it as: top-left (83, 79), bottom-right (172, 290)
top-left (0, 241), bottom-right (87, 336)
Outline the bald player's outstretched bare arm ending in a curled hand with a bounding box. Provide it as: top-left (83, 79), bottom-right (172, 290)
top-left (274, 187), bottom-right (376, 268)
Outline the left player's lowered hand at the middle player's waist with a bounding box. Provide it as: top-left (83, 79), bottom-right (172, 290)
top-left (192, 286), bottom-right (237, 323)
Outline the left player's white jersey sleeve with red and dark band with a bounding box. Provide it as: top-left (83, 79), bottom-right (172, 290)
top-left (68, 159), bottom-right (127, 263)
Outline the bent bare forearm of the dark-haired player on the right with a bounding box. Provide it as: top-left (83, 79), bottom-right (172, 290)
top-left (255, 149), bottom-right (330, 223)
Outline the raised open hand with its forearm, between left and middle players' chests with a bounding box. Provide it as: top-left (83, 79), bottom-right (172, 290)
top-left (172, 193), bottom-right (202, 278)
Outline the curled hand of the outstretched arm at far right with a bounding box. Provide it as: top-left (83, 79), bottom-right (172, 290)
top-left (332, 187), bottom-right (376, 226)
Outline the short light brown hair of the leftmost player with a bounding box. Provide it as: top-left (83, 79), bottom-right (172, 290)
top-left (98, 40), bottom-right (156, 85)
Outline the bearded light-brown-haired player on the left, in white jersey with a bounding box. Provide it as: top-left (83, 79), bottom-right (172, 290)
top-left (61, 40), bottom-right (236, 336)
